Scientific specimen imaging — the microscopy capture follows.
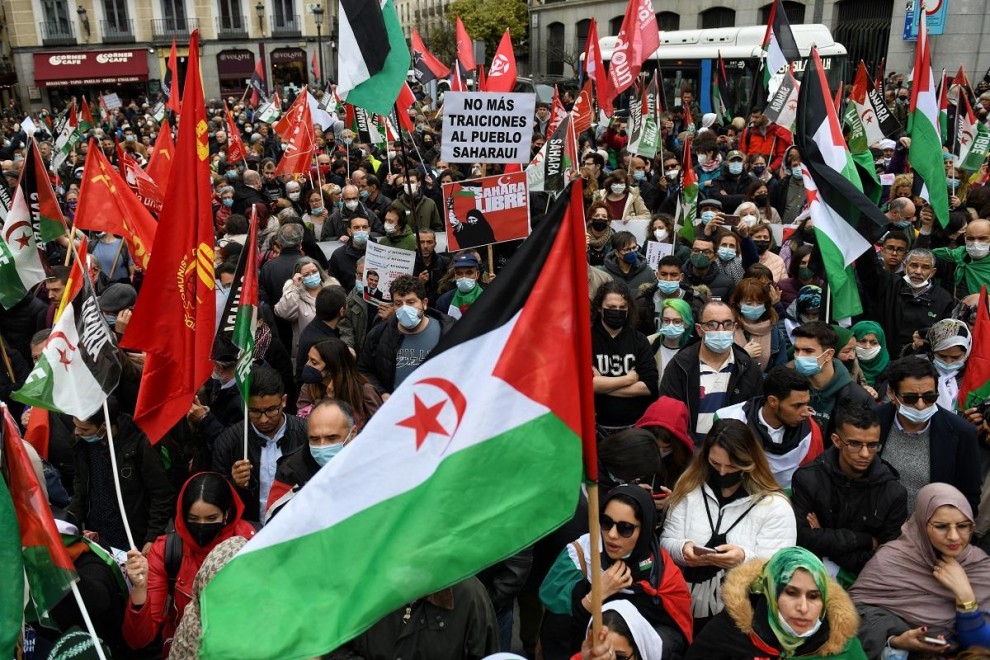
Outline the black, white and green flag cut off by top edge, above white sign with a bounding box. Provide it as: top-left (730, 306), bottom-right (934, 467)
top-left (337, 0), bottom-right (410, 115)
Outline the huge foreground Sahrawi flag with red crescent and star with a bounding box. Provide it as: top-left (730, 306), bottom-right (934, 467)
top-left (201, 184), bottom-right (594, 660)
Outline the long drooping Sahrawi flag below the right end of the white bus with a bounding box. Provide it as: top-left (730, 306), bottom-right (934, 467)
top-left (794, 48), bottom-right (888, 319)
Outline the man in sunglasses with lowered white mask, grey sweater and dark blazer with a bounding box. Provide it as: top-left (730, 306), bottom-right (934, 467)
top-left (877, 356), bottom-right (980, 513)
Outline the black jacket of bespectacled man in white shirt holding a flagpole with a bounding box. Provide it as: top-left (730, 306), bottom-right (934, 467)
top-left (213, 414), bottom-right (309, 521)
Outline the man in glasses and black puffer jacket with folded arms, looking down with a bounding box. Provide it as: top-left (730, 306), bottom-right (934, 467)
top-left (791, 405), bottom-right (908, 577)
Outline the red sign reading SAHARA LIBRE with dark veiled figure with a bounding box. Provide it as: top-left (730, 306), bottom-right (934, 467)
top-left (443, 172), bottom-right (530, 250)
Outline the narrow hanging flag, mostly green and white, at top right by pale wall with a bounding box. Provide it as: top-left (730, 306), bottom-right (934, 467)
top-left (908, 12), bottom-right (949, 227)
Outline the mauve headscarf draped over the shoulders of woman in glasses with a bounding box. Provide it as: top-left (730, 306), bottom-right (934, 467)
top-left (849, 483), bottom-right (990, 635)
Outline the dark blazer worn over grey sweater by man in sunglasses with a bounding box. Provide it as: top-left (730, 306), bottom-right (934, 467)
top-left (876, 403), bottom-right (982, 511)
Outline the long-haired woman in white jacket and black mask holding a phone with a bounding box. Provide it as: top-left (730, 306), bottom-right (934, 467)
top-left (660, 419), bottom-right (797, 632)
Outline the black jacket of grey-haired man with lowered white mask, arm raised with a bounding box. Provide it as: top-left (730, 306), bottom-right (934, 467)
top-left (856, 250), bottom-right (953, 355)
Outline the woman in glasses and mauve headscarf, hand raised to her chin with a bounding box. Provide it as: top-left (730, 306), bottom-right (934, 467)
top-left (849, 483), bottom-right (990, 658)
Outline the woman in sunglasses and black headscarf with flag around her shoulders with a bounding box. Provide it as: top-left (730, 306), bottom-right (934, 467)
top-left (540, 485), bottom-right (692, 660)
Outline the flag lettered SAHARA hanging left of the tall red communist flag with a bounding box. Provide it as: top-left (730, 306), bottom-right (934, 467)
top-left (11, 241), bottom-right (120, 419)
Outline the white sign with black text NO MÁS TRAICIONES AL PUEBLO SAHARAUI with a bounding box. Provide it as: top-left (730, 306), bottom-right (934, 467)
top-left (440, 92), bottom-right (536, 165)
